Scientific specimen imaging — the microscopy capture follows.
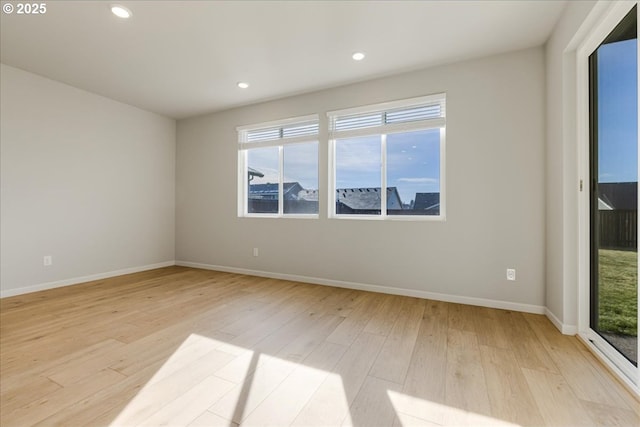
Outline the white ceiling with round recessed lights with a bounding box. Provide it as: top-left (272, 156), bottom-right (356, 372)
top-left (0, 0), bottom-right (566, 118)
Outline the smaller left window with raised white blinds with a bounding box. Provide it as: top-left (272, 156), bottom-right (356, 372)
top-left (238, 116), bottom-right (318, 217)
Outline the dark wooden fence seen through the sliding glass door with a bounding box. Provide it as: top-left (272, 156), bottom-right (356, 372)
top-left (599, 209), bottom-right (638, 250)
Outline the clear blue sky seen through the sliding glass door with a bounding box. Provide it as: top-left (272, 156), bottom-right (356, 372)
top-left (598, 39), bottom-right (638, 182)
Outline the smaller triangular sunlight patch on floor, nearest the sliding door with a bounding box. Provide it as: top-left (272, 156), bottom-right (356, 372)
top-left (387, 390), bottom-right (518, 427)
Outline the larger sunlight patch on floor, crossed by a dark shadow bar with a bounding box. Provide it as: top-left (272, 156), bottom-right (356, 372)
top-left (111, 334), bottom-right (349, 426)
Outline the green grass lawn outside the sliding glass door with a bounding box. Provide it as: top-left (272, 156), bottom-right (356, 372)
top-left (599, 249), bottom-right (638, 337)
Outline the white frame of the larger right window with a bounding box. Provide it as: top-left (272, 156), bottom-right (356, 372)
top-left (327, 93), bottom-right (446, 221)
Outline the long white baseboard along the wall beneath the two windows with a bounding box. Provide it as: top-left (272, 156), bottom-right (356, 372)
top-left (176, 261), bottom-right (546, 314)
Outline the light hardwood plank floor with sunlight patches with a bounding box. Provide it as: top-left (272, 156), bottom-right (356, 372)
top-left (0, 267), bottom-right (640, 427)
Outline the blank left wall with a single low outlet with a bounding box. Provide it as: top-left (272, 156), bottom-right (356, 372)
top-left (0, 65), bottom-right (175, 296)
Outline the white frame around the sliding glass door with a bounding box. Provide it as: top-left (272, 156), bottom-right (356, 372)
top-left (576, 1), bottom-right (640, 394)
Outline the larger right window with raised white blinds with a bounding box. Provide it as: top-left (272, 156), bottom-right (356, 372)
top-left (328, 94), bottom-right (445, 219)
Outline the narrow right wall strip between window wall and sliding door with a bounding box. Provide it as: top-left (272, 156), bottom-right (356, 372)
top-left (545, 1), bottom-right (596, 333)
